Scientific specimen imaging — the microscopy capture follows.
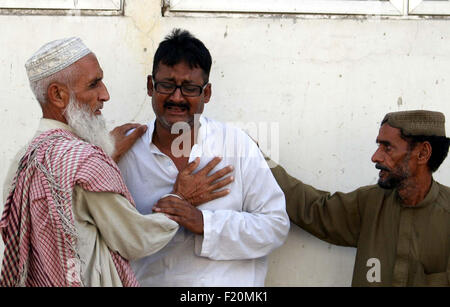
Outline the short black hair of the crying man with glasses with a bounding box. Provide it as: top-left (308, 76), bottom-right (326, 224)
top-left (152, 29), bottom-right (212, 83)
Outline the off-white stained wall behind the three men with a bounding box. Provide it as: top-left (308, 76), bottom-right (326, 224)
top-left (0, 0), bottom-right (450, 286)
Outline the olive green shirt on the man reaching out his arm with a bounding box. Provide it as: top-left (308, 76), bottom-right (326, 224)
top-left (271, 166), bottom-right (450, 286)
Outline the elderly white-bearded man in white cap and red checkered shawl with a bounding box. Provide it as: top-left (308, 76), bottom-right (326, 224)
top-left (0, 38), bottom-right (230, 286)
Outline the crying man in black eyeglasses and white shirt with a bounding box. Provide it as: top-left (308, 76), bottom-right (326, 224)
top-left (119, 29), bottom-right (289, 287)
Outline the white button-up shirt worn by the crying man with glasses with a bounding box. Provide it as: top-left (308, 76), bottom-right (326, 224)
top-left (119, 116), bottom-right (289, 287)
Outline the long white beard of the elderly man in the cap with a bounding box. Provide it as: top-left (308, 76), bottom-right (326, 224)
top-left (64, 95), bottom-right (115, 156)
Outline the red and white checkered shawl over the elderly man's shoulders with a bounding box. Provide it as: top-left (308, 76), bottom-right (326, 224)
top-left (0, 129), bottom-right (138, 286)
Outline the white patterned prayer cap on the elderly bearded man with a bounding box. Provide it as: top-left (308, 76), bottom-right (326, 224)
top-left (25, 37), bottom-right (91, 82)
